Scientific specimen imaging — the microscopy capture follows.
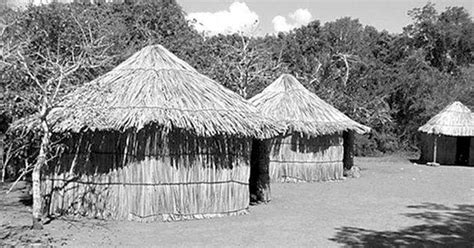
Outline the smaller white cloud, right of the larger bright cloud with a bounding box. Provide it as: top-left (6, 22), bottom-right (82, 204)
top-left (272, 9), bottom-right (313, 32)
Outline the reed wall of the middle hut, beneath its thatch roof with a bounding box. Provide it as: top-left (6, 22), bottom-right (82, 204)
top-left (270, 133), bottom-right (344, 182)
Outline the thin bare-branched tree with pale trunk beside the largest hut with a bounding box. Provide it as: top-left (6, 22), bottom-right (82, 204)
top-left (2, 4), bottom-right (114, 229)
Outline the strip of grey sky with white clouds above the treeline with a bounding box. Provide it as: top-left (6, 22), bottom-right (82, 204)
top-left (177, 0), bottom-right (474, 35)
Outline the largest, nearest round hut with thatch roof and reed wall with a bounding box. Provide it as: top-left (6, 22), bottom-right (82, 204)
top-left (13, 45), bottom-right (277, 221)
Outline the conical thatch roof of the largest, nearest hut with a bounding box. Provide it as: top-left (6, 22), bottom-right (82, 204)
top-left (13, 45), bottom-right (277, 137)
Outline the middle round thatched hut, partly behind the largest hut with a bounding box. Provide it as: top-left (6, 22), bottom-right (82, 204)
top-left (250, 74), bottom-right (370, 181)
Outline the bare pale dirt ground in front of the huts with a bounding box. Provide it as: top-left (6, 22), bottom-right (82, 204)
top-left (0, 156), bottom-right (474, 247)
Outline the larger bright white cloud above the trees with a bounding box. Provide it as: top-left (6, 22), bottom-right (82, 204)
top-left (187, 2), bottom-right (259, 35)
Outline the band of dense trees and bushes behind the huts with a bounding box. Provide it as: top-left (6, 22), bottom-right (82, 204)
top-left (0, 0), bottom-right (474, 161)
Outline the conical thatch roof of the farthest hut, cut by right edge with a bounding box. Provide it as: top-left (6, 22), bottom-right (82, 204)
top-left (418, 102), bottom-right (474, 136)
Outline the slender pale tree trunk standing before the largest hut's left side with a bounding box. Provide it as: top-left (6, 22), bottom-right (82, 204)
top-left (31, 107), bottom-right (51, 229)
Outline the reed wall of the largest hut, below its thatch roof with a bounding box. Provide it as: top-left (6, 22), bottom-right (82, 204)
top-left (42, 129), bottom-right (250, 221)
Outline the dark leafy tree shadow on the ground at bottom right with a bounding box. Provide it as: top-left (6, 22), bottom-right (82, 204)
top-left (329, 203), bottom-right (474, 247)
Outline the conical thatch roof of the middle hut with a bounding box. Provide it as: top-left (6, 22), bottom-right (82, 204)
top-left (250, 74), bottom-right (370, 136)
